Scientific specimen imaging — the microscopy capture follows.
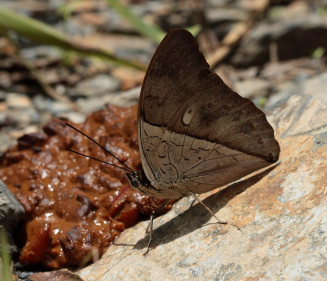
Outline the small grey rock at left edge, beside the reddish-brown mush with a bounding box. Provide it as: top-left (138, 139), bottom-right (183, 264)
top-left (0, 180), bottom-right (25, 233)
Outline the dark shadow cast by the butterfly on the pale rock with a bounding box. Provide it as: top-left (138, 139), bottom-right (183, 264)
top-left (133, 164), bottom-right (278, 250)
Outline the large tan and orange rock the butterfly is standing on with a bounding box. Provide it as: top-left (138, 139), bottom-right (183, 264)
top-left (80, 93), bottom-right (327, 281)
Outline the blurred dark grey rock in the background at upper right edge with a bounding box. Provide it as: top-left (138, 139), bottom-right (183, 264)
top-left (230, 15), bottom-right (327, 67)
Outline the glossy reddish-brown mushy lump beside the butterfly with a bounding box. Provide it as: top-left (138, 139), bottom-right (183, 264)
top-left (0, 106), bottom-right (172, 268)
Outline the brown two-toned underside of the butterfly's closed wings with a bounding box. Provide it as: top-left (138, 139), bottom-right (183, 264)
top-left (138, 29), bottom-right (280, 198)
